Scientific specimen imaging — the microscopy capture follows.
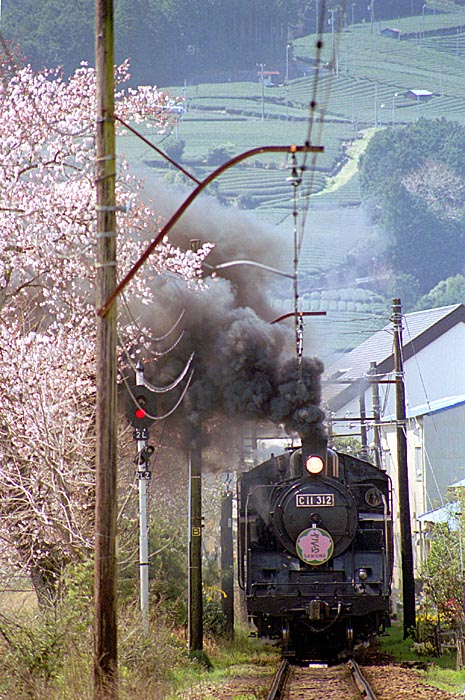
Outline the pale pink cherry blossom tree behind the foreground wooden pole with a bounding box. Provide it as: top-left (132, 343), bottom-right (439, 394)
top-left (0, 58), bottom-right (209, 602)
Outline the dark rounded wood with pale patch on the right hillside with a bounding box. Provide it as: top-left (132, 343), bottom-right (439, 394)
top-left (360, 119), bottom-right (465, 293)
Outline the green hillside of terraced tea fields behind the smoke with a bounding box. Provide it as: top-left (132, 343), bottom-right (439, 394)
top-left (119, 3), bottom-right (465, 360)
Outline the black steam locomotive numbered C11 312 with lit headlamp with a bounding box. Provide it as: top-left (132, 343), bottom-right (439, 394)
top-left (238, 438), bottom-right (393, 659)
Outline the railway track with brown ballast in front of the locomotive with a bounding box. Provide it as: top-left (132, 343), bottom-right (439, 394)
top-left (267, 660), bottom-right (376, 700)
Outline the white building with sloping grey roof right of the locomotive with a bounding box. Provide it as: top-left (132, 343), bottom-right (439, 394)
top-left (323, 304), bottom-right (465, 587)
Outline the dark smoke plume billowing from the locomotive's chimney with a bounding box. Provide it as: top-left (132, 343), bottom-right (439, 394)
top-left (140, 180), bottom-right (324, 437)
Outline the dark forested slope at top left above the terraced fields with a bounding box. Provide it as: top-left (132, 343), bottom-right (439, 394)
top-left (2, 0), bottom-right (315, 85)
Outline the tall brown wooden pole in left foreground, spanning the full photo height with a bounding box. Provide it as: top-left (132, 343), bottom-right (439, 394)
top-left (94, 0), bottom-right (118, 700)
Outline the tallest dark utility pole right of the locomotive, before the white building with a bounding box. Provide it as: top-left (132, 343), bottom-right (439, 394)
top-left (391, 299), bottom-right (416, 639)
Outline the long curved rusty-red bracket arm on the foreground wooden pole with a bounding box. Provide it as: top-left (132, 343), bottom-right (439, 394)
top-left (97, 144), bottom-right (324, 317)
